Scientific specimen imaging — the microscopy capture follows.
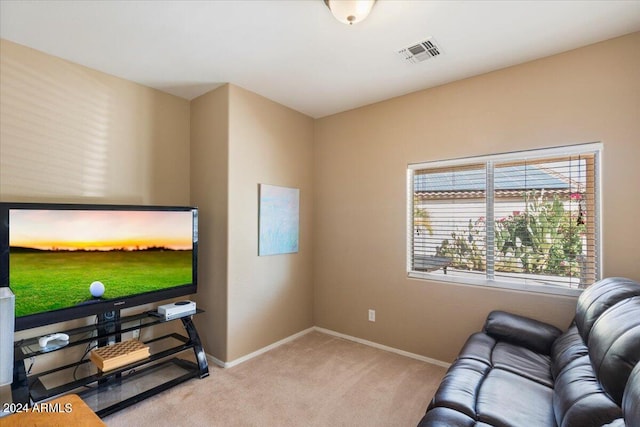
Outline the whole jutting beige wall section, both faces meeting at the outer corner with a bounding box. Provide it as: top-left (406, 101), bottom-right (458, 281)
top-left (191, 85), bottom-right (313, 362)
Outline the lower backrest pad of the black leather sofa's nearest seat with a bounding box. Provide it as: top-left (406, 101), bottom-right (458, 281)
top-left (553, 355), bottom-right (622, 427)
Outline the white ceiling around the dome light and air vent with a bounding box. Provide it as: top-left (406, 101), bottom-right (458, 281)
top-left (0, 0), bottom-right (640, 118)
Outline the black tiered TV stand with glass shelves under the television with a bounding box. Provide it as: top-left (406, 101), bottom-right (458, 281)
top-left (11, 309), bottom-right (209, 417)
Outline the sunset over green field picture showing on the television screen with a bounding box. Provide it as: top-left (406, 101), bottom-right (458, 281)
top-left (9, 209), bottom-right (195, 316)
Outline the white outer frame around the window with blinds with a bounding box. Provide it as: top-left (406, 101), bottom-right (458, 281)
top-left (406, 142), bottom-right (604, 296)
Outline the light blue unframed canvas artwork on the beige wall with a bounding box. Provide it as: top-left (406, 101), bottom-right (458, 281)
top-left (258, 184), bottom-right (300, 256)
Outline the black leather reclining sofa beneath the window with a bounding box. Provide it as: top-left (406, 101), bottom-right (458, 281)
top-left (419, 278), bottom-right (640, 427)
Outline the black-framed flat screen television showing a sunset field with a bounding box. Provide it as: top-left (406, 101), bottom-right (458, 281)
top-left (0, 202), bottom-right (198, 331)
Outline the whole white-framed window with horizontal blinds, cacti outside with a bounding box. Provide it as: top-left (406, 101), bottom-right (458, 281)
top-left (407, 144), bottom-right (602, 294)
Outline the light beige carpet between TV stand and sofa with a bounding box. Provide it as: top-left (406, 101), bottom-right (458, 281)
top-left (104, 332), bottom-right (445, 427)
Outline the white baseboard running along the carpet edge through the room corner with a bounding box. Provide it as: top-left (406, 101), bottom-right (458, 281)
top-left (207, 326), bottom-right (451, 368)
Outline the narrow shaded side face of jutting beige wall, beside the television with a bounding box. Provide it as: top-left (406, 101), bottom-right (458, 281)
top-left (191, 85), bottom-right (229, 361)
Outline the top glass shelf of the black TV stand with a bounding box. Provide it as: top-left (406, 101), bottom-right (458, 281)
top-left (14, 309), bottom-right (204, 360)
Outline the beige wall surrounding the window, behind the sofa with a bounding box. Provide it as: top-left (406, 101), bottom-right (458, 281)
top-left (314, 33), bottom-right (640, 361)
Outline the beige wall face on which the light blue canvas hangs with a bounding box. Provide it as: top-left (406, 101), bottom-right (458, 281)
top-left (227, 85), bottom-right (313, 361)
